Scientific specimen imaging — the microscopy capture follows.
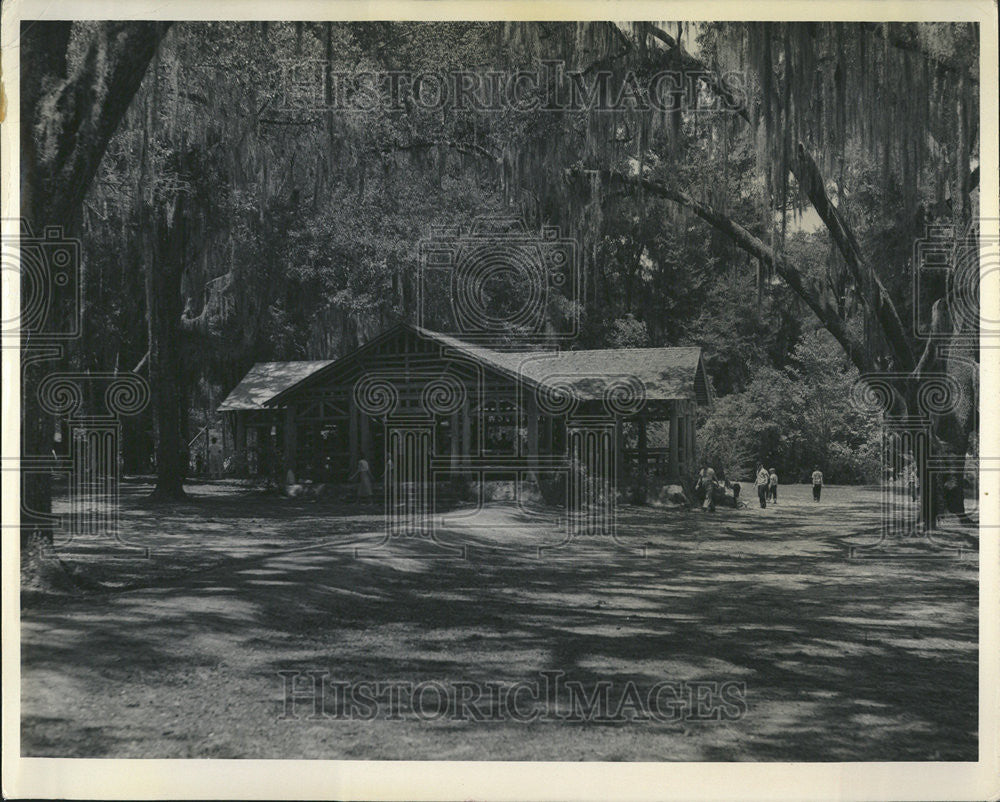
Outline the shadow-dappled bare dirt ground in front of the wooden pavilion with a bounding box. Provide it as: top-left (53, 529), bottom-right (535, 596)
top-left (21, 481), bottom-right (978, 761)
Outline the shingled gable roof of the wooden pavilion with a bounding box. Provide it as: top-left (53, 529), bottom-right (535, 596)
top-left (219, 323), bottom-right (712, 412)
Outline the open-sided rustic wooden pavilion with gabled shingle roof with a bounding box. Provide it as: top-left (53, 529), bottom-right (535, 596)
top-left (219, 324), bottom-right (712, 482)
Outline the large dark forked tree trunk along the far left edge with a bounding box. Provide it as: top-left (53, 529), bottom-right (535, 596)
top-left (19, 21), bottom-right (169, 552)
